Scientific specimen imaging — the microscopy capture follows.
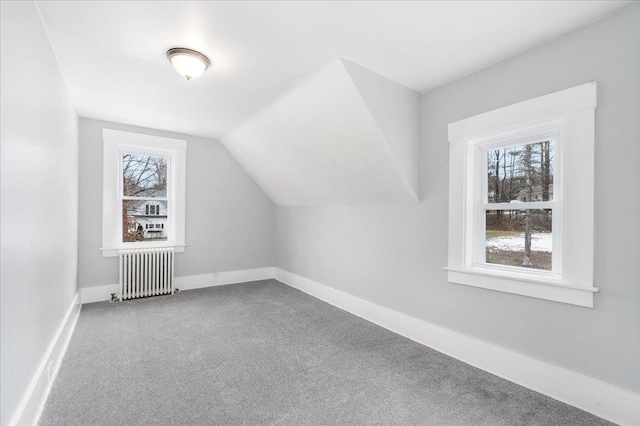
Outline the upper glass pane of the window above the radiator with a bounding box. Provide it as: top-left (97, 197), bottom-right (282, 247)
top-left (122, 154), bottom-right (167, 197)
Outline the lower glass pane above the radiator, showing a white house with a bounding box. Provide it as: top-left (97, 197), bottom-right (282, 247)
top-left (122, 199), bottom-right (168, 243)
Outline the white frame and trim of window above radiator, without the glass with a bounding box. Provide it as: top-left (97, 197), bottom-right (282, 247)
top-left (101, 129), bottom-right (187, 257)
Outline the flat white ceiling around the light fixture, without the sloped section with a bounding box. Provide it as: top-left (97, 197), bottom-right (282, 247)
top-left (38, 0), bottom-right (633, 138)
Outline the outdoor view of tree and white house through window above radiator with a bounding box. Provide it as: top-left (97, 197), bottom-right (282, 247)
top-left (122, 153), bottom-right (169, 242)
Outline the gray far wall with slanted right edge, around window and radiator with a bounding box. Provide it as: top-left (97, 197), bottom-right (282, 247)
top-left (78, 118), bottom-right (275, 287)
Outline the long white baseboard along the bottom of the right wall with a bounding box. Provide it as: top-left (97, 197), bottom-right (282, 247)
top-left (275, 268), bottom-right (640, 425)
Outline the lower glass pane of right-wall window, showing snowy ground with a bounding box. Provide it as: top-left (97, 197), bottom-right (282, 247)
top-left (485, 210), bottom-right (553, 271)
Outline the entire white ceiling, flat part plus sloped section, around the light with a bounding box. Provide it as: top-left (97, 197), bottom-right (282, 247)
top-left (36, 0), bottom-right (634, 205)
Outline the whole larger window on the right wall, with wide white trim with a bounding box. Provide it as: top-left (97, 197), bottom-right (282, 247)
top-left (446, 82), bottom-right (598, 307)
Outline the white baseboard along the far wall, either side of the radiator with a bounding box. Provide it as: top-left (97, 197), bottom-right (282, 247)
top-left (80, 267), bottom-right (274, 304)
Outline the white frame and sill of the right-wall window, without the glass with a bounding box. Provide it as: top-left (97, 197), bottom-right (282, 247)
top-left (445, 82), bottom-right (599, 307)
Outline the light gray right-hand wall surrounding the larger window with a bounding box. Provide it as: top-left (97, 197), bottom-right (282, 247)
top-left (276, 6), bottom-right (640, 392)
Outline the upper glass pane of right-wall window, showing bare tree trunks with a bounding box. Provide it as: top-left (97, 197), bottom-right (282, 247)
top-left (487, 140), bottom-right (554, 203)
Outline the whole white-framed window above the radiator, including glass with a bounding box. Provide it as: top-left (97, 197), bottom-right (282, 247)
top-left (102, 129), bottom-right (186, 256)
